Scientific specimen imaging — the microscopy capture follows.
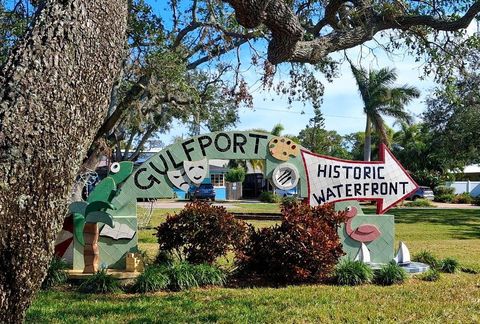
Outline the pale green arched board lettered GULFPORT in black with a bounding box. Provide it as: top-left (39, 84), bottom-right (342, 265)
top-left (119, 132), bottom-right (307, 203)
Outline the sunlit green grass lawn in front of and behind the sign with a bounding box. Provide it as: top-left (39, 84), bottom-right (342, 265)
top-left (27, 204), bottom-right (480, 323)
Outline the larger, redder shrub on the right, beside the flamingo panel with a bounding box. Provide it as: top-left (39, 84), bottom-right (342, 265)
top-left (236, 203), bottom-right (345, 284)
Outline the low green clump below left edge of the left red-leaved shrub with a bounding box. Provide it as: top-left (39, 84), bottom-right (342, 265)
top-left (132, 265), bottom-right (170, 293)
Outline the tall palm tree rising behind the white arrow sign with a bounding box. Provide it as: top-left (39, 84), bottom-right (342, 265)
top-left (350, 63), bottom-right (420, 161)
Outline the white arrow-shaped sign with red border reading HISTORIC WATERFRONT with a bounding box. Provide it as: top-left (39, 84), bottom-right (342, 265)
top-left (302, 144), bottom-right (418, 214)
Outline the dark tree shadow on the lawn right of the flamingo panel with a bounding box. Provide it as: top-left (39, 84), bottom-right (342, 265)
top-left (364, 208), bottom-right (480, 239)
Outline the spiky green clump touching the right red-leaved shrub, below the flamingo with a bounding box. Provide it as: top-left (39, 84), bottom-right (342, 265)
top-left (333, 259), bottom-right (373, 286)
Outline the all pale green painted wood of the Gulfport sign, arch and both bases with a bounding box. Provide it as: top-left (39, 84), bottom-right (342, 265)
top-left (70, 131), bottom-right (395, 269)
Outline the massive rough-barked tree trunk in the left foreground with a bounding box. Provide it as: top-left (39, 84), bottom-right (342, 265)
top-left (0, 0), bottom-right (127, 323)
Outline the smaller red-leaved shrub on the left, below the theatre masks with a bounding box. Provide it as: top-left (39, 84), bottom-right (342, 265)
top-left (156, 202), bottom-right (246, 264)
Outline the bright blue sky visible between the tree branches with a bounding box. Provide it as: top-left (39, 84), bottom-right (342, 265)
top-left (147, 0), bottom-right (476, 144)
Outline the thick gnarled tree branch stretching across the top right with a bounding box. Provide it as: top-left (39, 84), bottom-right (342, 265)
top-left (223, 0), bottom-right (480, 64)
